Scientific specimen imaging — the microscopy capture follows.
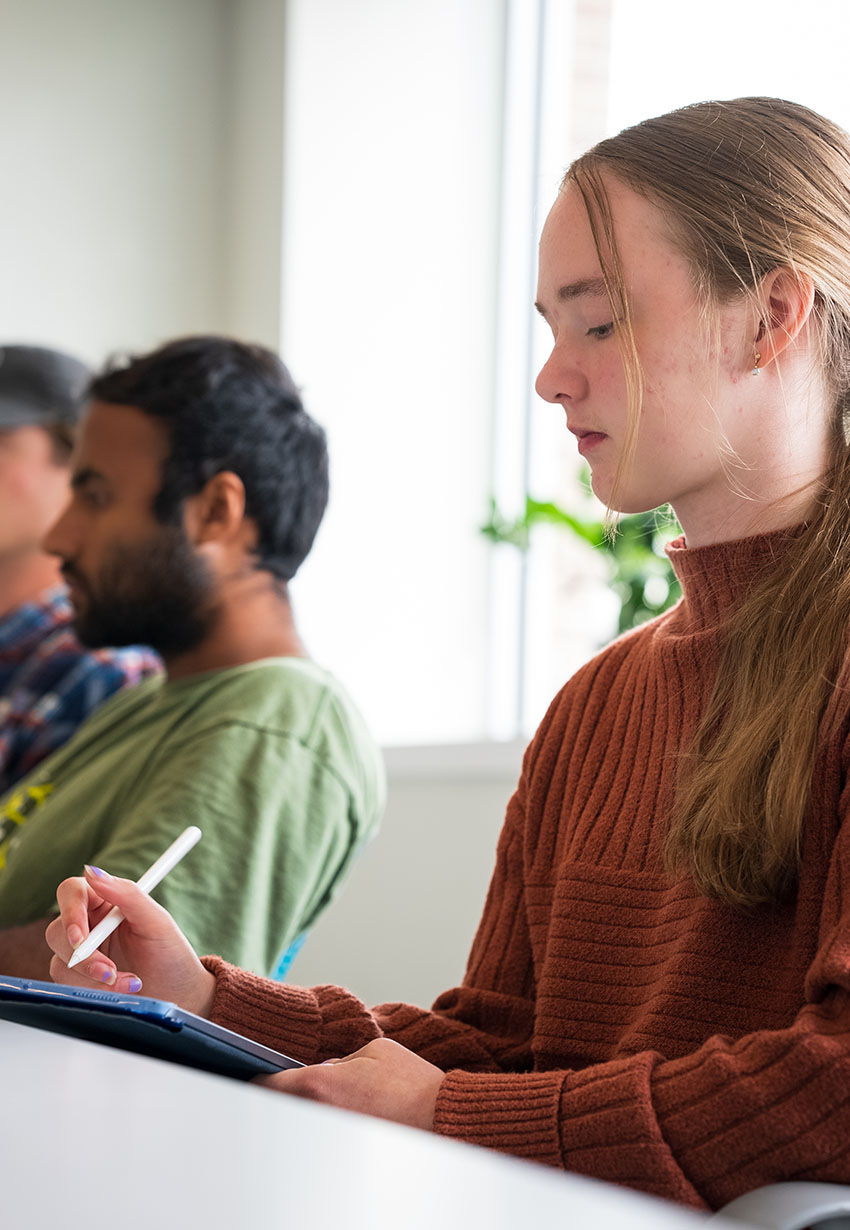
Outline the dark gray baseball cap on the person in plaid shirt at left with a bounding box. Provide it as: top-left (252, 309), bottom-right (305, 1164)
top-left (0, 346), bottom-right (91, 429)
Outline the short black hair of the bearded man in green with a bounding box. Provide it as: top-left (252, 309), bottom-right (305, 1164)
top-left (89, 337), bottom-right (328, 581)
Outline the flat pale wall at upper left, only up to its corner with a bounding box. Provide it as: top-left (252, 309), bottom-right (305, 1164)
top-left (0, 0), bottom-right (223, 362)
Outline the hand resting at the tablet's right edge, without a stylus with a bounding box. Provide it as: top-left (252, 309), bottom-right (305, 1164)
top-left (256, 1038), bottom-right (445, 1130)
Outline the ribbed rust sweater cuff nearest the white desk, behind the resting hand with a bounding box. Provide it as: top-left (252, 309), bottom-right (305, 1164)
top-left (434, 1069), bottom-right (565, 1166)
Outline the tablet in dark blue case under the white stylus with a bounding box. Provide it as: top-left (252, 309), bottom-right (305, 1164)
top-left (0, 974), bottom-right (303, 1080)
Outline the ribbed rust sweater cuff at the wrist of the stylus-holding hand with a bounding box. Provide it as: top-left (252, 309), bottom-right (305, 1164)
top-left (201, 957), bottom-right (321, 1064)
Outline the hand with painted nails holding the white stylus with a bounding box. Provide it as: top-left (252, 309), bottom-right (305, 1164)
top-left (44, 867), bottom-right (215, 1016)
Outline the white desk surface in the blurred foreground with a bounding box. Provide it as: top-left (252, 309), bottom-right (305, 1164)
top-left (0, 1021), bottom-right (752, 1230)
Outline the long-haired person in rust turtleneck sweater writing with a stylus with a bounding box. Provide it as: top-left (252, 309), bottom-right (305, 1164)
top-left (48, 98), bottom-right (850, 1208)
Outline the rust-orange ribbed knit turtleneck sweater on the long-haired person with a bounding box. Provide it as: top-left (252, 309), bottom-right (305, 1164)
top-left (201, 534), bottom-right (850, 1208)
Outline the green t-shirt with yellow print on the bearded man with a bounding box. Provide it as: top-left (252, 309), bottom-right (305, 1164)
top-left (0, 658), bottom-right (385, 974)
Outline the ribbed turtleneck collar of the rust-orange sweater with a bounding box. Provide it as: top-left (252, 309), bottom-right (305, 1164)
top-left (667, 526), bottom-right (801, 631)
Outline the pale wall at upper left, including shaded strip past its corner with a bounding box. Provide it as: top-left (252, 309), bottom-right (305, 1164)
top-left (0, 0), bottom-right (284, 363)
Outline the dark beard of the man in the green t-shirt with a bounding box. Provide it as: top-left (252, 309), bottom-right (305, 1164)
top-left (63, 525), bottom-right (214, 658)
